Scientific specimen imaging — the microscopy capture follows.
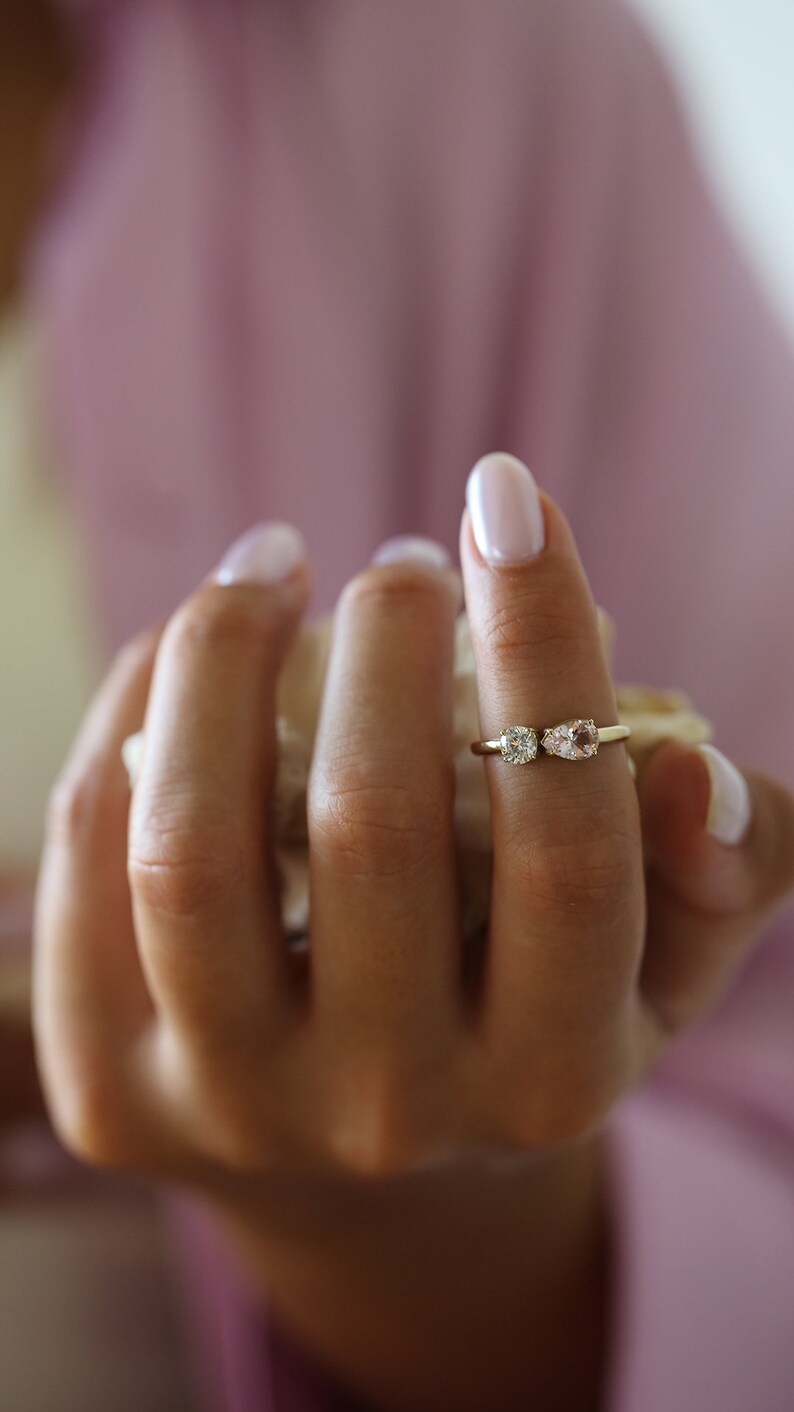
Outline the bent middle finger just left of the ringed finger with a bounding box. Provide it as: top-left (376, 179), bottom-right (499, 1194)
top-left (309, 541), bottom-right (461, 1146)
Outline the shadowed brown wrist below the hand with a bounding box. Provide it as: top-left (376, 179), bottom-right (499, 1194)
top-left (203, 1138), bottom-right (609, 1412)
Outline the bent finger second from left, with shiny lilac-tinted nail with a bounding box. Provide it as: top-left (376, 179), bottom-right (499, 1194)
top-left (129, 525), bottom-right (309, 1082)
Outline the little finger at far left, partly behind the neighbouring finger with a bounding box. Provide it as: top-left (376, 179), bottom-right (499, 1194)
top-left (34, 628), bottom-right (160, 1148)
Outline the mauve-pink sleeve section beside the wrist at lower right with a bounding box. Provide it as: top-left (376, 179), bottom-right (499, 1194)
top-left (606, 1094), bottom-right (794, 1412)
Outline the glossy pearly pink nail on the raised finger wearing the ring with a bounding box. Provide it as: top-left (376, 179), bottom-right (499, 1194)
top-left (466, 450), bottom-right (545, 563)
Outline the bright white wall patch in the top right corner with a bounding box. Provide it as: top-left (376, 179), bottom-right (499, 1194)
top-left (630, 0), bottom-right (794, 337)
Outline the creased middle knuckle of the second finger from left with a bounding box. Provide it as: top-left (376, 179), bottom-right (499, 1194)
top-left (127, 813), bottom-right (254, 918)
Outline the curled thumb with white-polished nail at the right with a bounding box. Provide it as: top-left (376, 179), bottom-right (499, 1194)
top-left (639, 744), bottom-right (794, 1031)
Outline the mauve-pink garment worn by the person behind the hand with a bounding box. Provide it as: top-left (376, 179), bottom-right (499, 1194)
top-left (21, 0), bottom-right (794, 1412)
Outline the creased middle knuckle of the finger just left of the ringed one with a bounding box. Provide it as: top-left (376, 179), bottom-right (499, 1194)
top-left (309, 761), bottom-right (452, 877)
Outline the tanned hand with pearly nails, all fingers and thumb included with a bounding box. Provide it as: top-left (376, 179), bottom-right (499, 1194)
top-left (35, 456), bottom-right (794, 1408)
